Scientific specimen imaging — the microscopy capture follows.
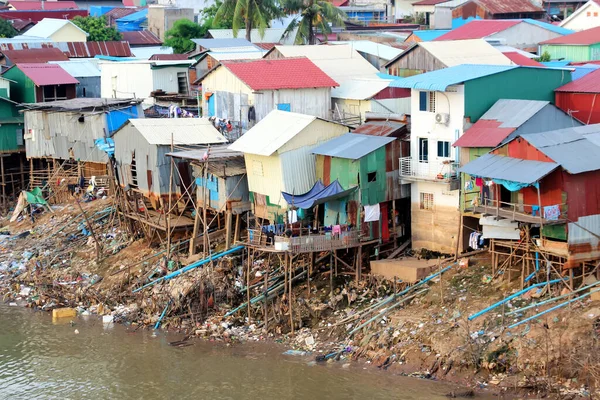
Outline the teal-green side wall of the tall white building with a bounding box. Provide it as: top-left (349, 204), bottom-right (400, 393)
top-left (465, 68), bottom-right (571, 122)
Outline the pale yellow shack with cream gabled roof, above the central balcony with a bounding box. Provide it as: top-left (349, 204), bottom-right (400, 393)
top-left (229, 110), bottom-right (349, 224)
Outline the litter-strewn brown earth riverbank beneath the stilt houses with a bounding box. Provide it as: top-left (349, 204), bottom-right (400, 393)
top-left (0, 199), bottom-right (600, 397)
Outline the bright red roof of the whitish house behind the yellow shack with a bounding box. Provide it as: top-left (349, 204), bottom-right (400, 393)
top-left (221, 57), bottom-right (338, 90)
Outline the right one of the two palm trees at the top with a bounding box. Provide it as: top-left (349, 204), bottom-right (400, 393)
top-left (283, 0), bottom-right (346, 44)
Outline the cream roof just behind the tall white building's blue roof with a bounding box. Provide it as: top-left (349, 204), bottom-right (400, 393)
top-left (417, 39), bottom-right (512, 67)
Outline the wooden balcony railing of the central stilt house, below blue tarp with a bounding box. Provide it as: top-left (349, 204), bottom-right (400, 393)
top-left (248, 229), bottom-right (360, 253)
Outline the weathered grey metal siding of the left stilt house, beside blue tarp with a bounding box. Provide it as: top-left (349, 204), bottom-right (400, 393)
top-left (24, 111), bottom-right (108, 163)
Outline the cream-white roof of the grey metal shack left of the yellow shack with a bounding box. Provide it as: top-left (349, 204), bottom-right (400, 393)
top-left (125, 118), bottom-right (227, 145)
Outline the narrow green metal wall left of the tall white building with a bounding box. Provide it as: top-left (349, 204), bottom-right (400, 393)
top-left (360, 147), bottom-right (387, 205)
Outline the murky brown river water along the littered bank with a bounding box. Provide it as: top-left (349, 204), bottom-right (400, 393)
top-left (0, 305), bottom-right (478, 400)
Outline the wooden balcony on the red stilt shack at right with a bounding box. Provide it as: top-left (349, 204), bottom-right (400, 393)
top-left (464, 199), bottom-right (567, 225)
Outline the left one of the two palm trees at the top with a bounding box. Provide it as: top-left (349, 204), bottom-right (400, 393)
top-left (215, 0), bottom-right (282, 41)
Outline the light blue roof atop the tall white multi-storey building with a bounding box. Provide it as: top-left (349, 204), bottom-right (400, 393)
top-left (389, 64), bottom-right (519, 92)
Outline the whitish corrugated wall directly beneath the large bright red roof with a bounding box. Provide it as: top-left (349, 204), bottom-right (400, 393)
top-left (254, 88), bottom-right (331, 121)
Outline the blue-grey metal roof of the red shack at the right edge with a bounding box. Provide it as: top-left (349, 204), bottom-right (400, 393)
top-left (521, 124), bottom-right (600, 174)
